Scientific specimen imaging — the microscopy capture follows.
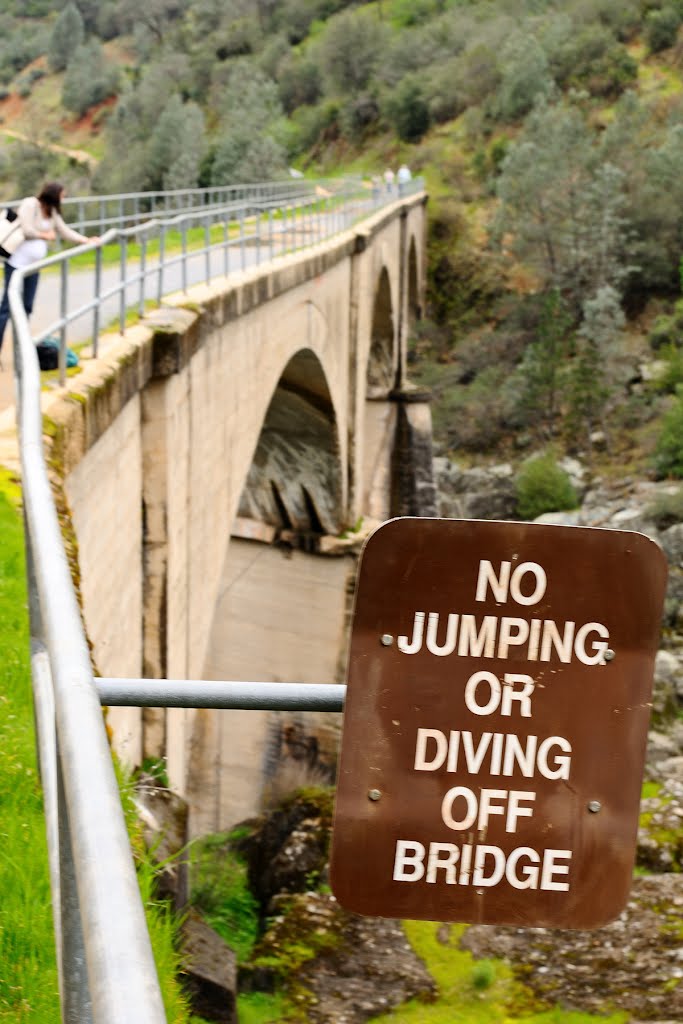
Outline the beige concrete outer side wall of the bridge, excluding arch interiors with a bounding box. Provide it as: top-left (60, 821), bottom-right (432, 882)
top-left (45, 197), bottom-right (424, 791)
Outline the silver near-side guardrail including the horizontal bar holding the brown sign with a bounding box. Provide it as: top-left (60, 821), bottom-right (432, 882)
top-left (9, 183), bottom-right (421, 1024)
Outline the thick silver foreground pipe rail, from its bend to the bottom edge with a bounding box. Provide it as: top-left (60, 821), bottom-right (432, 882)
top-left (8, 268), bottom-right (166, 1024)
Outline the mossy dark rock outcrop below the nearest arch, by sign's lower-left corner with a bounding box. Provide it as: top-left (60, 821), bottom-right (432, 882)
top-left (236, 790), bottom-right (435, 1024)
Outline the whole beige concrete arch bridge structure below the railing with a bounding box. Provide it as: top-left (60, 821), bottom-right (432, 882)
top-left (45, 194), bottom-right (434, 833)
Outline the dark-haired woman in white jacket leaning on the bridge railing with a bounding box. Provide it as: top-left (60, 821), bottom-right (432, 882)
top-left (0, 181), bottom-right (99, 362)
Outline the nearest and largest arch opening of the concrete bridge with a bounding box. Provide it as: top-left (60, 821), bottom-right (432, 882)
top-left (193, 349), bottom-right (353, 836)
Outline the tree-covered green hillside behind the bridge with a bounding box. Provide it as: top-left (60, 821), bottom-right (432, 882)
top-left (0, 0), bottom-right (683, 483)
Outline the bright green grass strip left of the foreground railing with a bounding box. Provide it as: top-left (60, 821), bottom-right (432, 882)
top-left (0, 471), bottom-right (59, 1024)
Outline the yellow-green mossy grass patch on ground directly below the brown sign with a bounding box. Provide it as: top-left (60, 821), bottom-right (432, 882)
top-left (373, 921), bottom-right (628, 1024)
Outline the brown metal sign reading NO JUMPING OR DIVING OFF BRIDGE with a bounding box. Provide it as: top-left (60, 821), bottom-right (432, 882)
top-left (331, 519), bottom-right (667, 928)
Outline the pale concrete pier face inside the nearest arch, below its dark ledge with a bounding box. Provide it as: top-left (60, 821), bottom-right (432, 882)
top-left (188, 539), bottom-right (355, 835)
